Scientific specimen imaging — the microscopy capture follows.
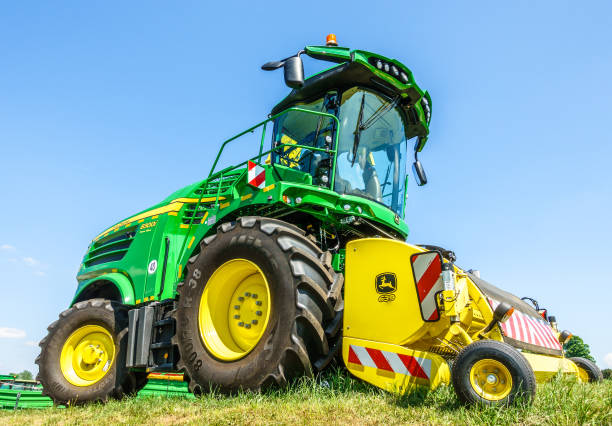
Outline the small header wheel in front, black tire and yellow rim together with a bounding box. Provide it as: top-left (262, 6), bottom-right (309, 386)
top-left (452, 340), bottom-right (536, 405)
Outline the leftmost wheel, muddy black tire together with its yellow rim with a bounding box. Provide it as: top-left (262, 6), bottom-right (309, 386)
top-left (36, 299), bottom-right (146, 405)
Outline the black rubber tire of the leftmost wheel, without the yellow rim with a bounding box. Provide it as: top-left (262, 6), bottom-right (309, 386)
top-left (36, 299), bottom-right (146, 405)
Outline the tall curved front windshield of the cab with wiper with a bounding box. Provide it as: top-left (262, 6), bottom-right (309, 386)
top-left (334, 88), bottom-right (414, 214)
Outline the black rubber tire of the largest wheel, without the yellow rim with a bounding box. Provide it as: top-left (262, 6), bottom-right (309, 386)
top-left (174, 217), bottom-right (343, 394)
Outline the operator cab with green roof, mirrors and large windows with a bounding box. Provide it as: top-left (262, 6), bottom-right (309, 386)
top-left (264, 37), bottom-right (431, 216)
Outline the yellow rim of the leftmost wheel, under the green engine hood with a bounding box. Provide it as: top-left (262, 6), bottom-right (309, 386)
top-left (60, 325), bottom-right (115, 387)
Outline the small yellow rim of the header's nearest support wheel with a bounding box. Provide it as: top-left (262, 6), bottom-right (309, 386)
top-left (470, 359), bottom-right (512, 401)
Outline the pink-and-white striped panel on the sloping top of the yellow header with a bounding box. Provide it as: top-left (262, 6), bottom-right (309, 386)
top-left (489, 298), bottom-right (563, 351)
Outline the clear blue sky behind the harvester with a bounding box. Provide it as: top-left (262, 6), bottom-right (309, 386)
top-left (0, 1), bottom-right (612, 372)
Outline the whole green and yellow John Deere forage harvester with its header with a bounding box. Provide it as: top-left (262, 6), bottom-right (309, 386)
top-left (37, 37), bottom-right (601, 404)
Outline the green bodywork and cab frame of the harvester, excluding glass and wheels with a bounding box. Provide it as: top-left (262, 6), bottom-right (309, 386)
top-left (71, 46), bottom-right (431, 305)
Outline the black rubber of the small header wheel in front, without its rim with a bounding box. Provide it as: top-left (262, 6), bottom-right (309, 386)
top-left (451, 340), bottom-right (536, 405)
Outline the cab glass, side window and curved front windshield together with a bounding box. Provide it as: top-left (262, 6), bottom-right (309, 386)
top-left (271, 87), bottom-right (407, 215)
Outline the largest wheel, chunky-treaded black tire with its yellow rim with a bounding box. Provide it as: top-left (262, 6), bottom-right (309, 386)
top-left (174, 217), bottom-right (343, 394)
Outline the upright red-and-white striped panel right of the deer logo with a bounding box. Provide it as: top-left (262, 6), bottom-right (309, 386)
top-left (411, 252), bottom-right (444, 321)
